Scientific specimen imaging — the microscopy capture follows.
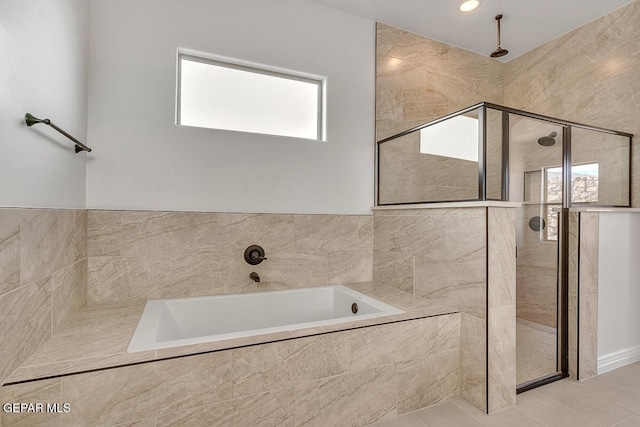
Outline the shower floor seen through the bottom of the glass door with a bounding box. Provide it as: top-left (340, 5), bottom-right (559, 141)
top-left (516, 319), bottom-right (557, 384)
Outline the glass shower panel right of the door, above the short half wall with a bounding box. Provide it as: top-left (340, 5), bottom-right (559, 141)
top-left (571, 128), bottom-right (629, 206)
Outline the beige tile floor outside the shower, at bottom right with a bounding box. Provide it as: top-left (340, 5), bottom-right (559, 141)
top-left (374, 362), bottom-right (640, 427)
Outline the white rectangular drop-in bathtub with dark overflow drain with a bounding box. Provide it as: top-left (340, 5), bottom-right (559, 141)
top-left (127, 285), bottom-right (404, 353)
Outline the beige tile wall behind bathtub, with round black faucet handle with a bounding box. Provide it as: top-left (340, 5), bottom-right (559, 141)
top-left (87, 210), bottom-right (373, 303)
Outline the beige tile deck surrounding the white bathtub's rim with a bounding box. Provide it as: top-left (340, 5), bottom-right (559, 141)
top-left (4, 282), bottom-right (459, 386)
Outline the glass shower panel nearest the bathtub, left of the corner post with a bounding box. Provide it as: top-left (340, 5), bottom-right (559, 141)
top-left (378, 110), bottom-right (479, 204)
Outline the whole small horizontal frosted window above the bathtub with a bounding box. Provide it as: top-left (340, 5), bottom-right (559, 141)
top-left (177, 54), bottom-right (323, 140)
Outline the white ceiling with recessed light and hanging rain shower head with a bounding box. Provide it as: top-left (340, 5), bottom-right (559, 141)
top-left (312, 0), bottom-right (632, 62)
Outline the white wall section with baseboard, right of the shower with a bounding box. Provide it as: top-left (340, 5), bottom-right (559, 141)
top-left (598, 212), bottom-right (640, 373)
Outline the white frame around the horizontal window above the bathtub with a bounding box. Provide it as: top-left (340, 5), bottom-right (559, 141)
top-left (176, 50), bottom-right (327, 141)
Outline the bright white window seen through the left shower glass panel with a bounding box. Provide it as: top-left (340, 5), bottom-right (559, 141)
top-left (420, 116), bottom-right (478, 162)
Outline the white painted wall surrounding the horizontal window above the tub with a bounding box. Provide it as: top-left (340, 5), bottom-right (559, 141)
top-left (87, 0), bottom-right (375, 214)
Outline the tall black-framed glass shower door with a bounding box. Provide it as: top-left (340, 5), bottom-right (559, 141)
top-left (509, 114), bottom-right (562, 385)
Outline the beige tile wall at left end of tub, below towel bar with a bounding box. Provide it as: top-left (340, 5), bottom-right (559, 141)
top-left (0, 208), bottom-right (87, 383)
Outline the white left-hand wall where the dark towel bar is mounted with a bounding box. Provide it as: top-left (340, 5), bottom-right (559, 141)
top-left (0, 0), bottom-right (89, 208)
